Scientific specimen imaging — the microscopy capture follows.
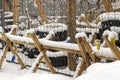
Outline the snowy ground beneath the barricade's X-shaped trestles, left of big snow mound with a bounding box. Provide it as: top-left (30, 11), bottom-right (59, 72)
top-left (0, 61), bottom-right (73, 80)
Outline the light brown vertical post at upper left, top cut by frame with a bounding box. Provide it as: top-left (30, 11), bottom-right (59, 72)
top-left (13, 0), bottom-right (19, 24)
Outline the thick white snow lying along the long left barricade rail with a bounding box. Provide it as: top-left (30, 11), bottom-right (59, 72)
top-left (2, 34), bottom-right (79, 50)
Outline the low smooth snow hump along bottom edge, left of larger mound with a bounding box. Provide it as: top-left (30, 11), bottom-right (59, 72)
top-left (14, 73), bottom-right (73, 80)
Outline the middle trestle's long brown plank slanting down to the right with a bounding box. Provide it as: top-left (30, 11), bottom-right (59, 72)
top-left (31, 33), bottom-right (56, 73)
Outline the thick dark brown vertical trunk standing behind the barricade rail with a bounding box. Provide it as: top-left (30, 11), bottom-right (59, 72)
top-left (67, 0), bottom-right (77, 71)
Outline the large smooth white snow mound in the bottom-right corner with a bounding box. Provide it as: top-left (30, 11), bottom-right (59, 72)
top-left (75, 61), bottom-right (120, 80)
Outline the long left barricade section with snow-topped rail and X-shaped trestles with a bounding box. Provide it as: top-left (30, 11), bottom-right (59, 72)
top-left (0, 32), bottom-right (90, 75)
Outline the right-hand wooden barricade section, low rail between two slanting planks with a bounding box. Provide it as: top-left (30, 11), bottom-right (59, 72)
top-left (79, 32), bottom-right (120, 62)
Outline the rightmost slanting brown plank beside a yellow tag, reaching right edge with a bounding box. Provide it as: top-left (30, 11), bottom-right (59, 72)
top-left (104, 35), bottom-right (120, 60)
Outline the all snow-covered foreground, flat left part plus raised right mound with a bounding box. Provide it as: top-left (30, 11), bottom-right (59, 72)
top-left (0, 58), bottom-right (120, 80)
